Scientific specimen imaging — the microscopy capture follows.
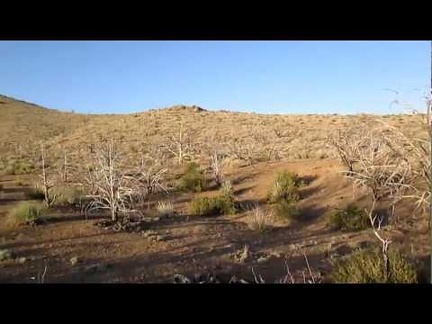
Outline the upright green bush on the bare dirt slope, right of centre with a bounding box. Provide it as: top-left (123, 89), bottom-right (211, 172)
top-left (267, 171), bottom-right (302, 203)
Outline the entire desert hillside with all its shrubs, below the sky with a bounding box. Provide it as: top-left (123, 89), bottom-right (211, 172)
top-left (0, 96), bottom-right (430, 283)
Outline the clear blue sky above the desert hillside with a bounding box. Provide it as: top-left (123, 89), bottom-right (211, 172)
top-left (0, 41), bottom-right (430, 114)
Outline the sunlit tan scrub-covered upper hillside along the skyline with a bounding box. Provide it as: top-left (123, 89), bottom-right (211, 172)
top-left (0, 96), bottom-right (424, 166)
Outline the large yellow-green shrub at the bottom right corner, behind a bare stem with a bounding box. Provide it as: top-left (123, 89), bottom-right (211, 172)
top-left (331, 249), bottom-right (418, 283)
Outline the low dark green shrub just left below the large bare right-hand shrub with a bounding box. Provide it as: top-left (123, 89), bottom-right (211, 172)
top-left (328, 204), bottom-right (371, 231)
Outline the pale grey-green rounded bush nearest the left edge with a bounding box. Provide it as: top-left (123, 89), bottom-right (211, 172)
top-left (8, 202), bottom-right (45, 226)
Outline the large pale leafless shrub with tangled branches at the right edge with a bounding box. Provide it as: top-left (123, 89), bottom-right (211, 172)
top-left (340, 110), bottom-right (430, 281)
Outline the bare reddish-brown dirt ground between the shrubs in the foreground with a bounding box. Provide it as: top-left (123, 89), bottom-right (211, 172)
top-left (0, 159), bottom-right (429, 283)
